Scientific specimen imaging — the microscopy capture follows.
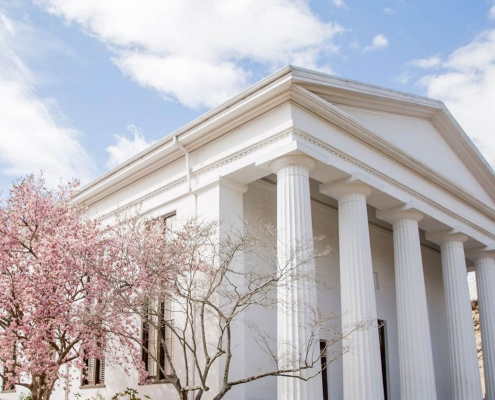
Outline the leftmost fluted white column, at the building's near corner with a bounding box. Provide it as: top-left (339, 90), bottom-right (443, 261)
top-left (270, 155), bottom-right (322, 400)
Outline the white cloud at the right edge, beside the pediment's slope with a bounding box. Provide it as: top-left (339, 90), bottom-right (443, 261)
top-left (419, 30), bottom-right (495, 167)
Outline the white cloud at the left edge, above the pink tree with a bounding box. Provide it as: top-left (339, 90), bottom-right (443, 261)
top-left (0, 11), bottom-right (96, 186)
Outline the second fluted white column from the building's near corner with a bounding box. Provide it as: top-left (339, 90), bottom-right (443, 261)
top-left (320, 182), bottom-right (384, 400)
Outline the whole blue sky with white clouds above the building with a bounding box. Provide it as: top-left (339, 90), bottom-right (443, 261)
top-left (0, 0), bottom-right (495, 191)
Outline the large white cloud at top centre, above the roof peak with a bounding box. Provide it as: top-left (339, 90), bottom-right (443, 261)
top-left (38, 0), bottom-right (343, 108)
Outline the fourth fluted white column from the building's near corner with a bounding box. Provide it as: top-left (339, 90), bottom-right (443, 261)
top-left (440, 234), bottom-right (482, 400)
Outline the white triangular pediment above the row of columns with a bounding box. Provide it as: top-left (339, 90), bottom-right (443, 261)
top-left (292, 68), bottom-right (495, 210)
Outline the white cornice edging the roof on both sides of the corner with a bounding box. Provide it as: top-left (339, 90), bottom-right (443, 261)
top-left (74, 66), bottom-right (495, 208)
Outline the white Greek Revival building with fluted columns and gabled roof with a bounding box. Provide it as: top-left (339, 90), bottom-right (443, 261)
top-left (70, 67), bottom-right (495, 400)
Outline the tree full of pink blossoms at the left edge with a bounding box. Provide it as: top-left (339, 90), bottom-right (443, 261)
top-left (0, 176), bottom-right (138, 400)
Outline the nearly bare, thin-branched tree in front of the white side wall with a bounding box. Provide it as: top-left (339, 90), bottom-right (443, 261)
top-left (100, 215), bottom-right (352, 400)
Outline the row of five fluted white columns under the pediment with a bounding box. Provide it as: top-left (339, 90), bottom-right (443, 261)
top-left (270, 155), bottom-right (495, 400)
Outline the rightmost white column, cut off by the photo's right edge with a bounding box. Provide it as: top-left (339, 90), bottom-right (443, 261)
top-left (475, 255), bottom-right (495, 400)
